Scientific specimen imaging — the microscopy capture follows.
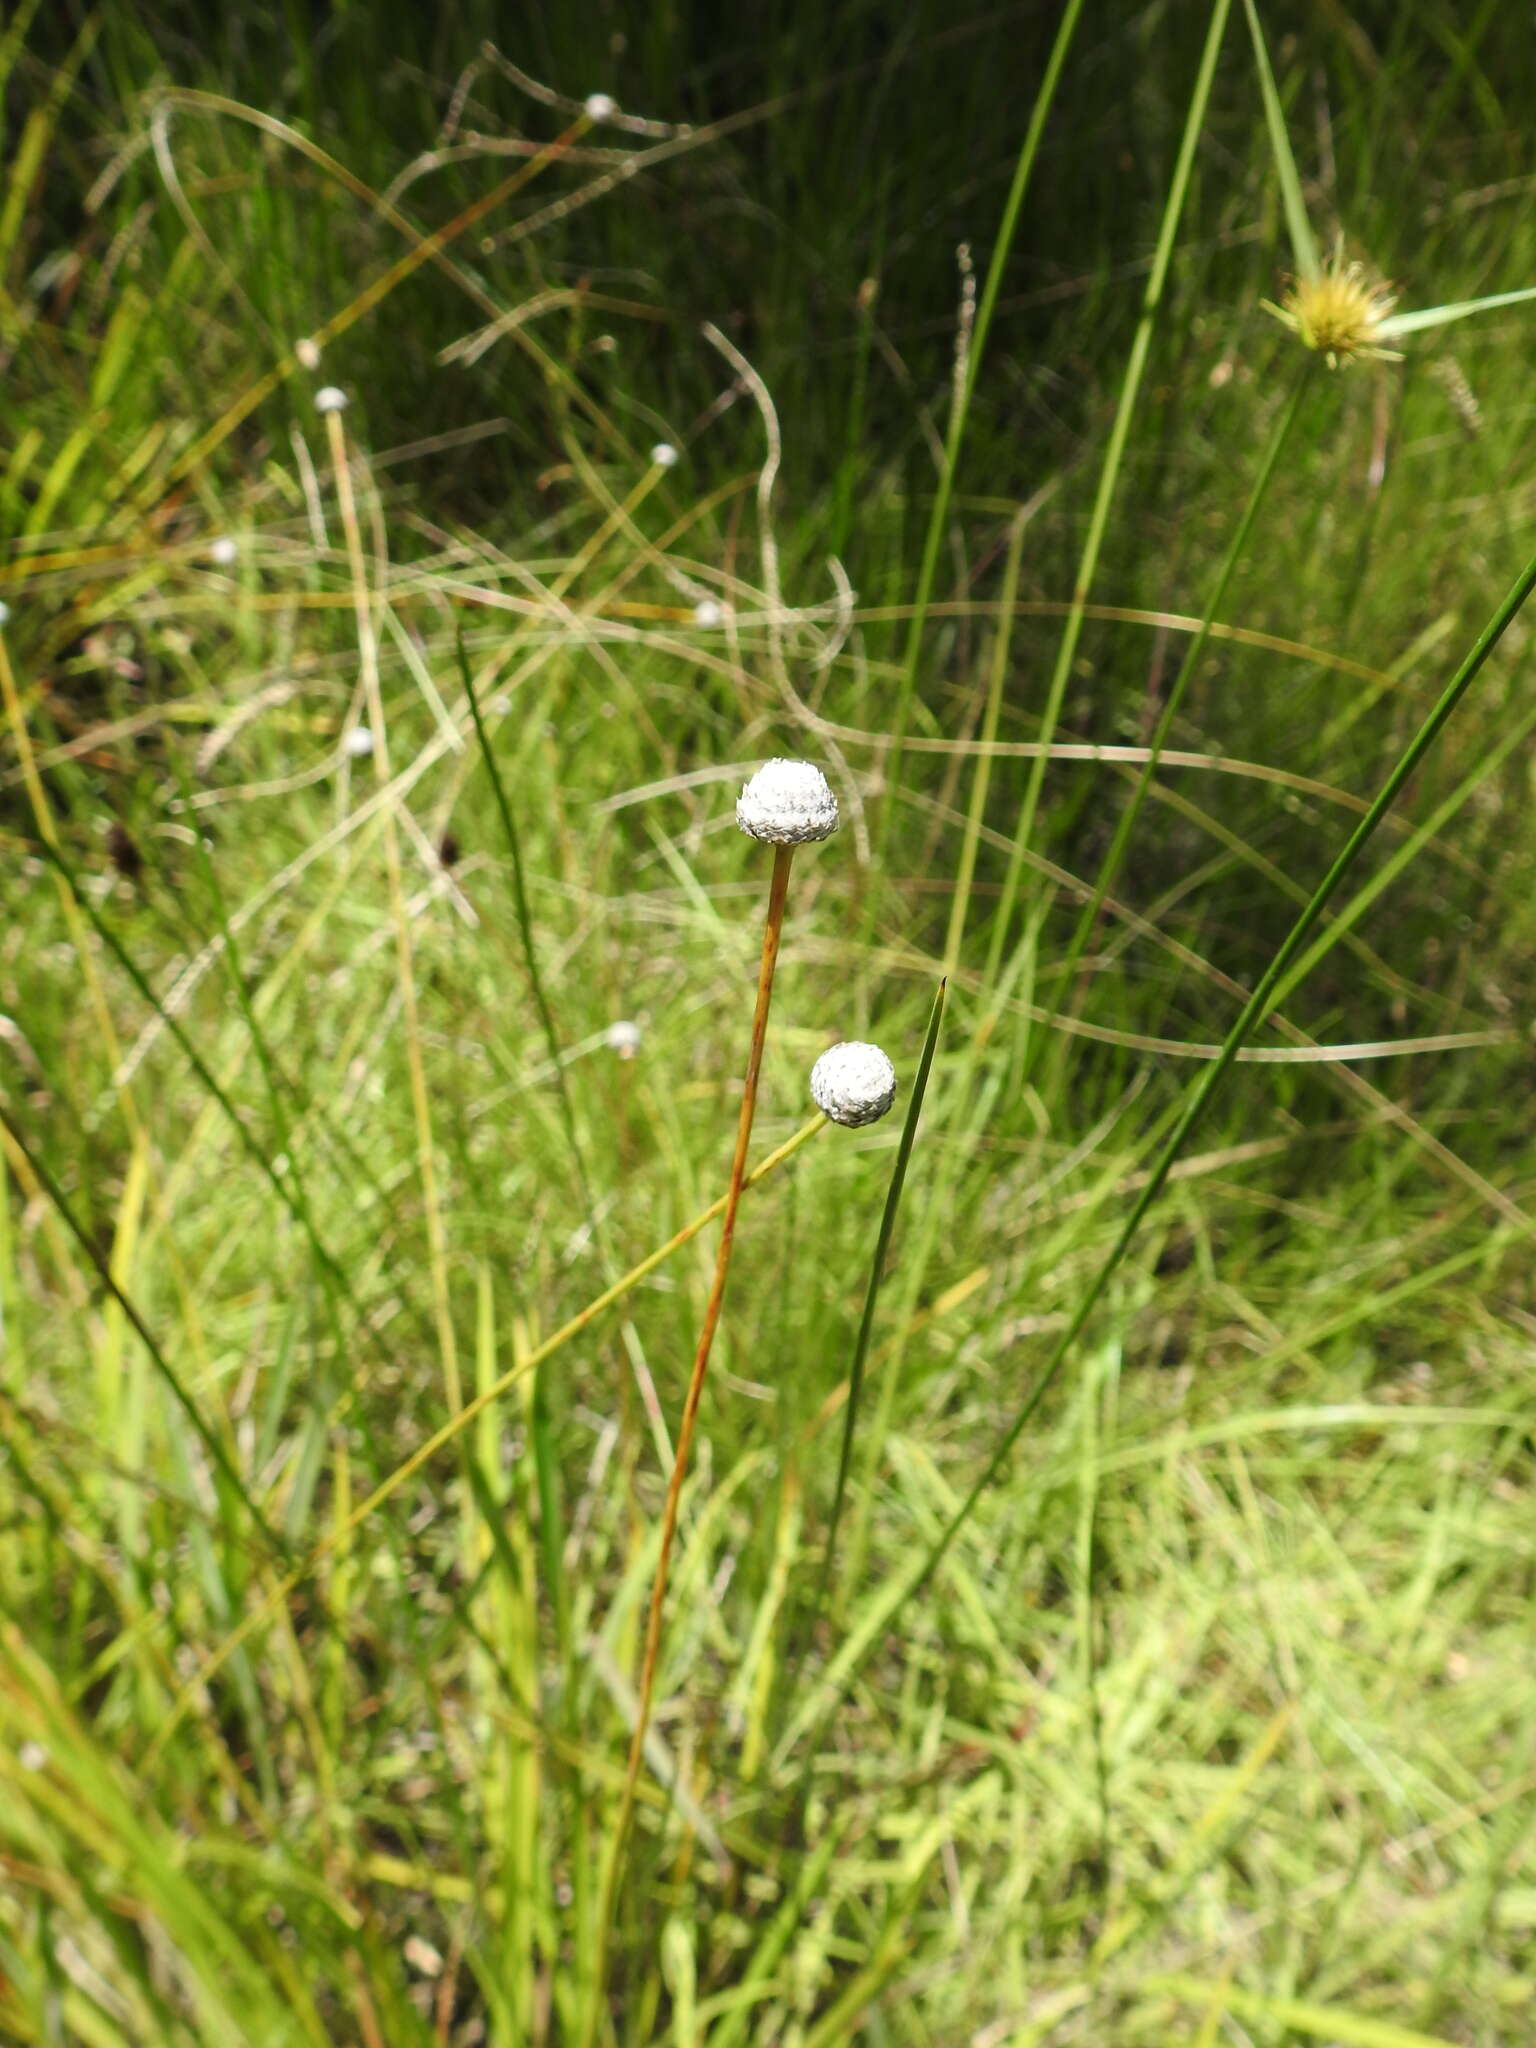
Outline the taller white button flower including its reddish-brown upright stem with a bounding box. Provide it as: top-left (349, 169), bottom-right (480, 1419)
top-left (598, 760), bottom-right (838, 1933)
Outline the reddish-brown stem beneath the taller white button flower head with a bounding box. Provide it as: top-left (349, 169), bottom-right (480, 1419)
top-left (586, 846), bottom-right (795, 2040)
